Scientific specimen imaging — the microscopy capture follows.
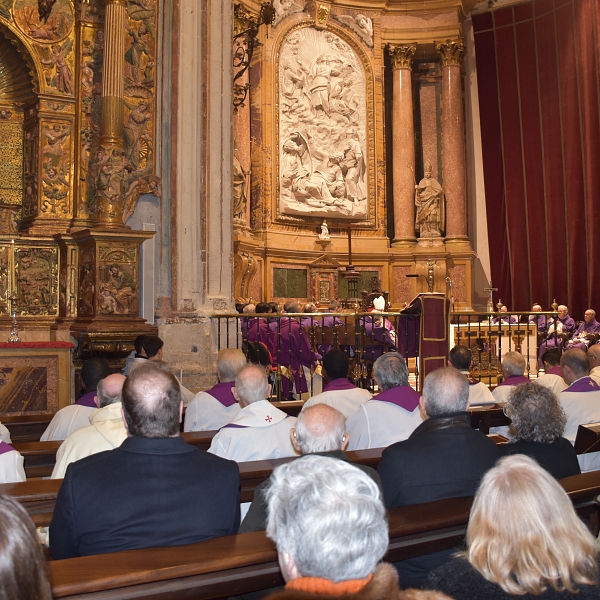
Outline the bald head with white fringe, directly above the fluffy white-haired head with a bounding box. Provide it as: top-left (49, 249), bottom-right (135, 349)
top-left (290, 404), bottom-right (349, 454)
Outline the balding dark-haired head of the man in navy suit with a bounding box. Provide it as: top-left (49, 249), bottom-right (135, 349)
top-left (123, 363), bottom-right (182, 438)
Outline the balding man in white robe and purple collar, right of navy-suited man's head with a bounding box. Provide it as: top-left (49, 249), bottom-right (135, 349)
top-left (183, 348), bottom-right (246, 431)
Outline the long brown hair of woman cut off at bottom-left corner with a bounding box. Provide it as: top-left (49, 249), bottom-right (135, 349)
top-left (0, 496), bottom-right (52, 600)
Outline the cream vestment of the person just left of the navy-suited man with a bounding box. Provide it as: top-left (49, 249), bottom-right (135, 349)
top-left (51, 402), bottom-right (127, 479)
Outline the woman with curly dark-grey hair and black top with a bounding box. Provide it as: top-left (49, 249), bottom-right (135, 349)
top-left (501, 383), bottom-right (581, 479)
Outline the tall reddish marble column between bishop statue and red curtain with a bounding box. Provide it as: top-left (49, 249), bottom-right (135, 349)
top-left (436, 40), bottom-right (468, 245)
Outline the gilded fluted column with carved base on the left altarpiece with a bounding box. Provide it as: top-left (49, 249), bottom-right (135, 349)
top-left (96, 0), bottom-right (127, 229)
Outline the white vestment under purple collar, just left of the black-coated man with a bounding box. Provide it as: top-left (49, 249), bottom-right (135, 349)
top-left (346, 400), bottom-right (423, 450)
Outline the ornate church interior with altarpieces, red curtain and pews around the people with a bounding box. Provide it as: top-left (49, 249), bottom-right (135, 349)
top-left (0, 0), bottom-right (600, 600)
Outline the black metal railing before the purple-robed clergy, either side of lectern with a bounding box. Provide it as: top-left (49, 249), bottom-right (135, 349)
top-left (212, 312), bottom-right (561, 400)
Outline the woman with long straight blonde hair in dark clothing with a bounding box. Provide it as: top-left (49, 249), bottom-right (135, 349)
top-left (426, 454), bottom-right (600, 600)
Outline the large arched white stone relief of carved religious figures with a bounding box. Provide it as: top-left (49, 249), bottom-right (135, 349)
top-left (279, 27), bottom-right (368, 219)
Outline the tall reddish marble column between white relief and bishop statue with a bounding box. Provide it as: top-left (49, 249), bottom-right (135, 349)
top-left (389, 44), bottom-right (417, 248)
